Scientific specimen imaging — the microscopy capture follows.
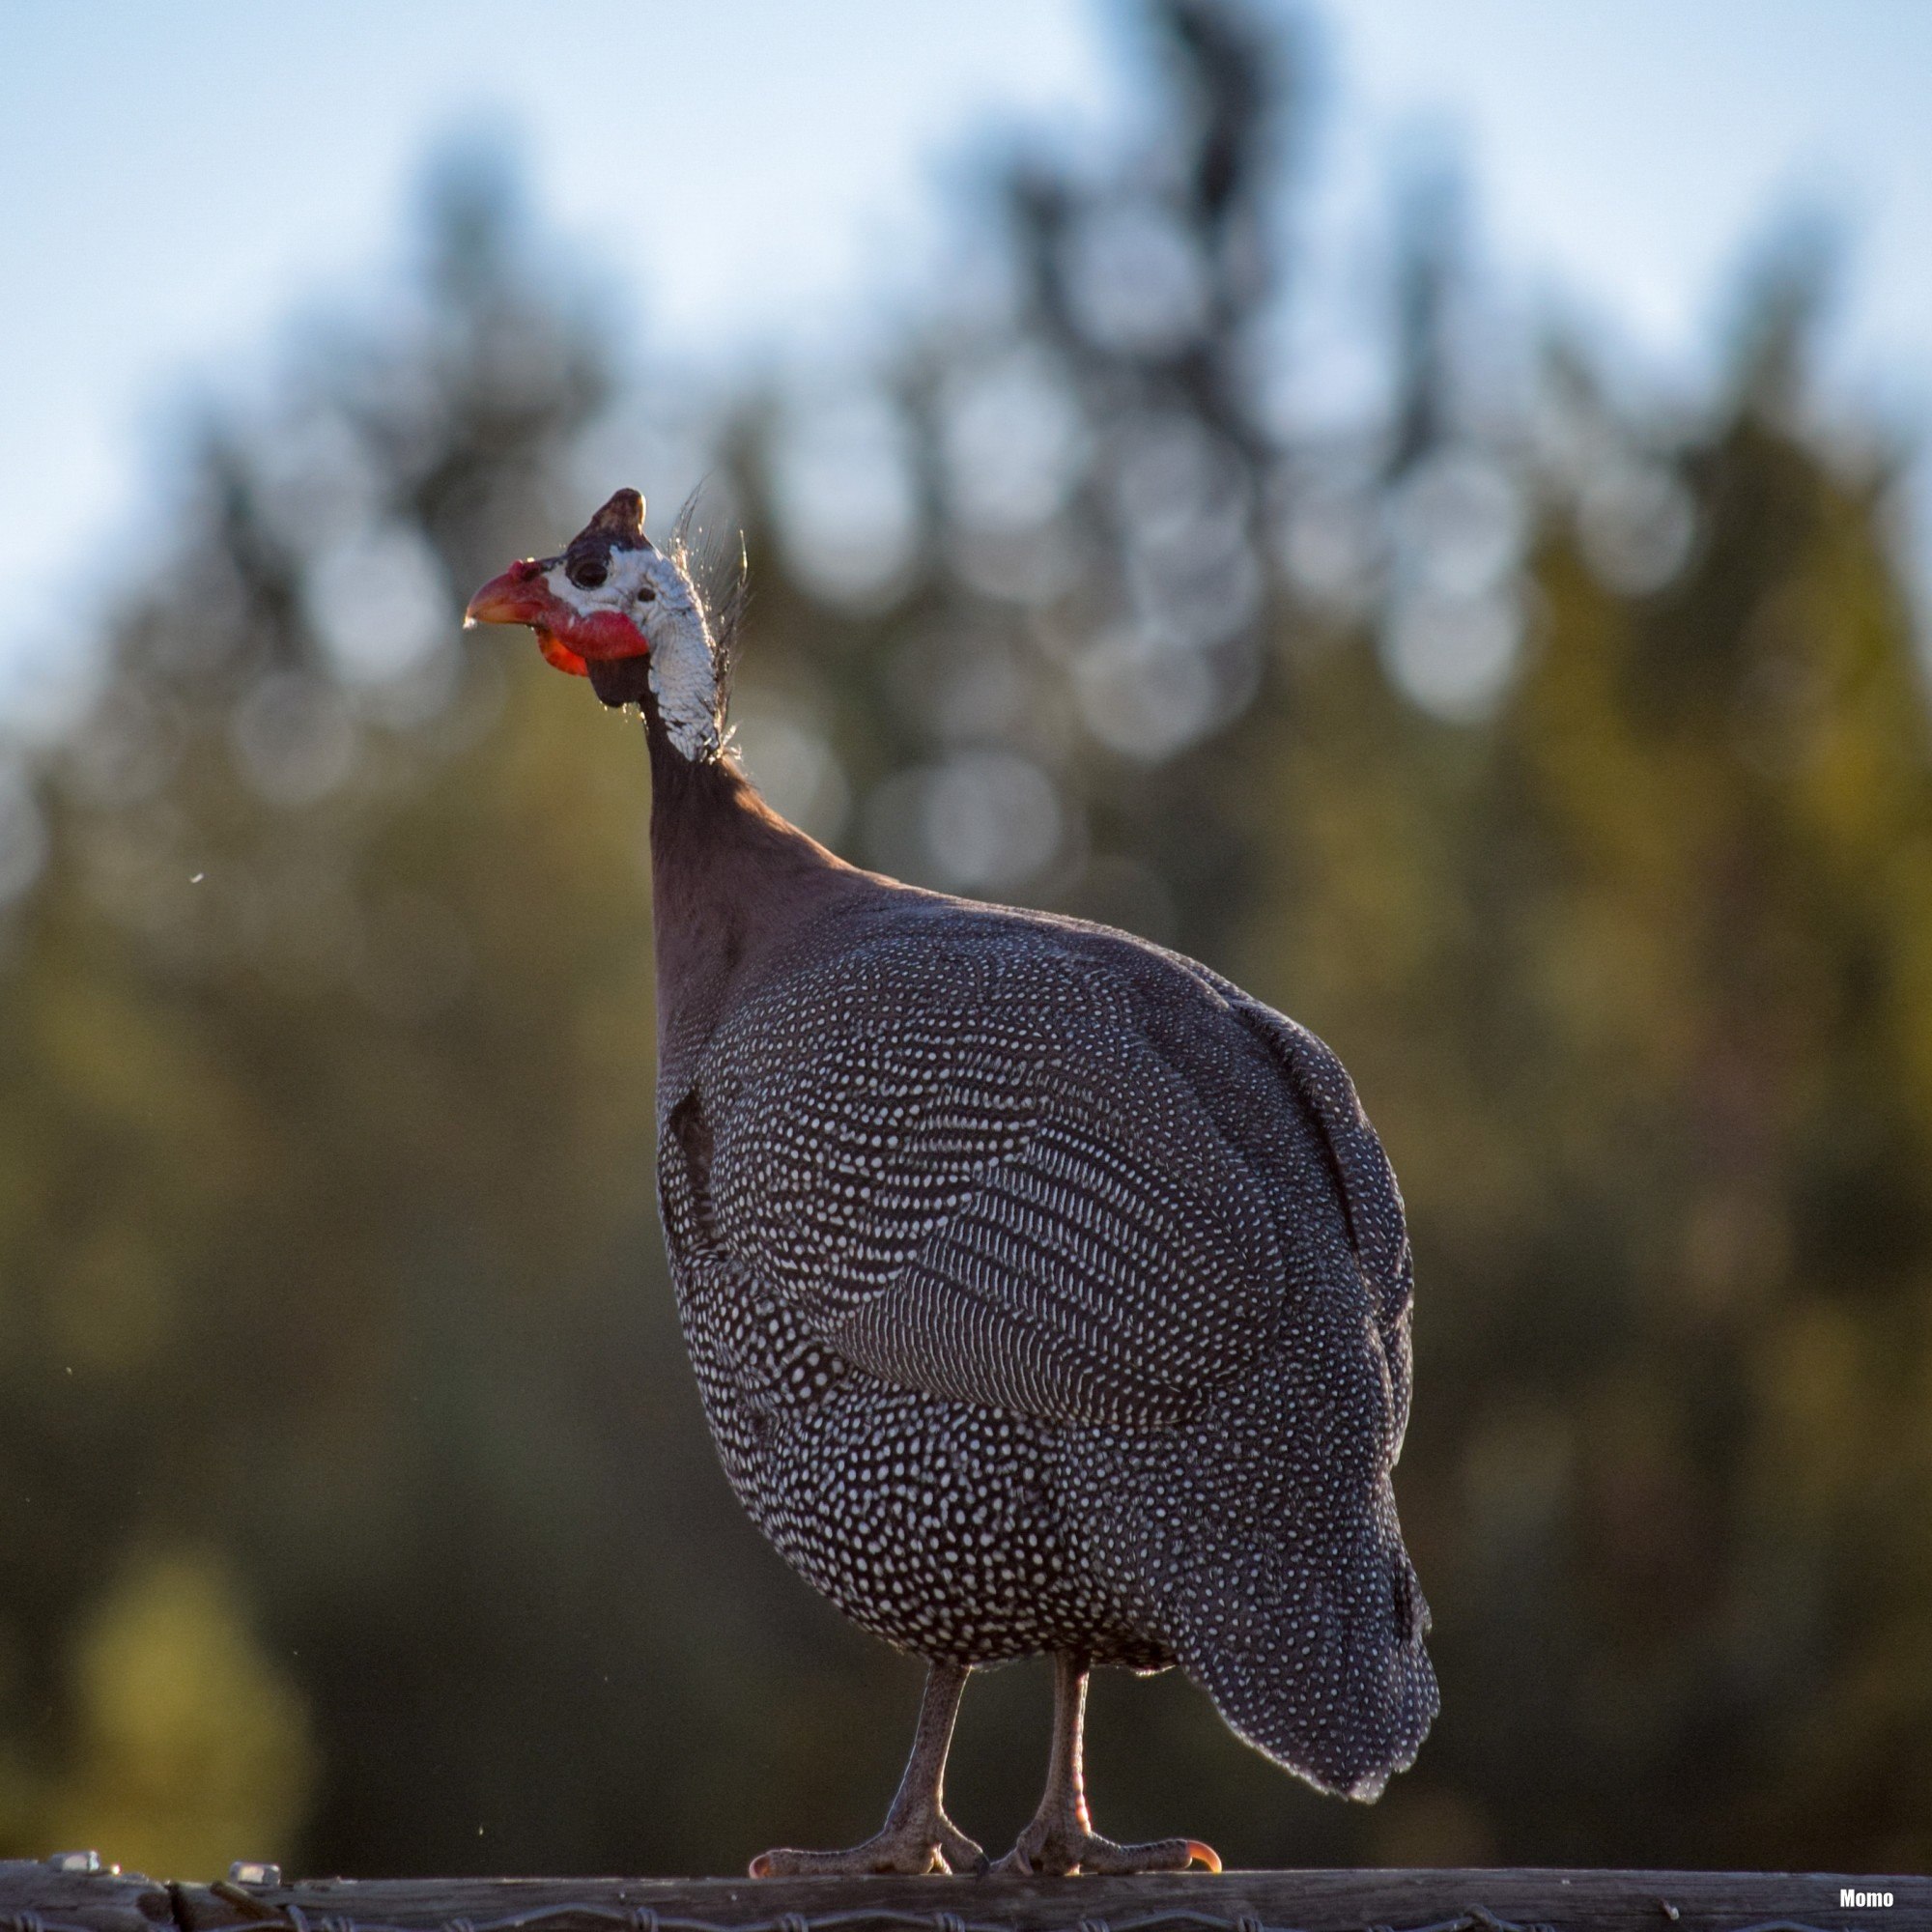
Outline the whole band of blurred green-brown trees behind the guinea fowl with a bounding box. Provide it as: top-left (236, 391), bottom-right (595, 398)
top-left (0, 0), bottom-right (1932, 1878)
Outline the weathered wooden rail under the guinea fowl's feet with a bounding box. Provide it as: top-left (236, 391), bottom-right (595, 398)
top-left (0, 1853), bottom-right (1932, 1932)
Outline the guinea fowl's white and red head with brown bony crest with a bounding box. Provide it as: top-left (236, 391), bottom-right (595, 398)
top-left (464, 489), bottom-right (724, 759)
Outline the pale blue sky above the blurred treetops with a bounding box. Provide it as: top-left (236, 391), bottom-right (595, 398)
top-left (0, 0), bottom-right (1932, 711)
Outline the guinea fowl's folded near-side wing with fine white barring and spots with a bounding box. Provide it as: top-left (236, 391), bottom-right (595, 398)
top-left (688, 939), bottom-right (1289, 1426)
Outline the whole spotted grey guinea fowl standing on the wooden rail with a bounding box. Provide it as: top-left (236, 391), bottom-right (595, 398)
top-left (468, 491), bottom-right (1437, 1876)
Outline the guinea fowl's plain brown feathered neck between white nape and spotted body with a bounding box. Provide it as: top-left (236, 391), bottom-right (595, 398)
top-left (647, 707), bottom-right (873, 1094)
